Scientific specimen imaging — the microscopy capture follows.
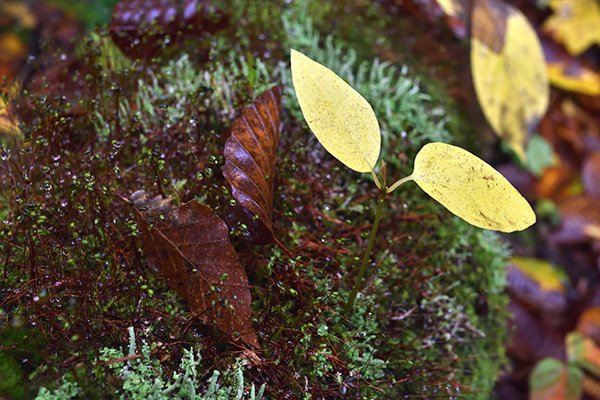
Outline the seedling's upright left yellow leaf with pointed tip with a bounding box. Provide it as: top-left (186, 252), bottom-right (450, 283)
top-left (291, 50), bottom-right (381, 172)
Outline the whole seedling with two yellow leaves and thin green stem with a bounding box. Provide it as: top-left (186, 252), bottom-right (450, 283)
top-left (291, 50), bottom-right (536, 311)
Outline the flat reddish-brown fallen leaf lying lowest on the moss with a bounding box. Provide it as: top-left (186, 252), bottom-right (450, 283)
top-left (130, 191), bottom-right (259, 347)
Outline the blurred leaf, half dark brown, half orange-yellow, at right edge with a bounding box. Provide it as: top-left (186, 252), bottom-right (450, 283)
top-left (542, 38), bottom-right (600, 96)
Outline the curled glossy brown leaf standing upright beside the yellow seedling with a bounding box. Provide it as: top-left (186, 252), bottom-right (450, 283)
top-left (223, 87), bottom-right (281, 239)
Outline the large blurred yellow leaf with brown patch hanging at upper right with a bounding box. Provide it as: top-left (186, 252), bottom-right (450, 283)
top-left (471, 0), bottom-right (550, 160)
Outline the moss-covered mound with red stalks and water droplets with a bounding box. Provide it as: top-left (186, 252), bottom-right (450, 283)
top-left (0, 1), bottom-right (506, 399)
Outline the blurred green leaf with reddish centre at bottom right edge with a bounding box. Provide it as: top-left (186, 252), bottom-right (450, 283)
top-left (529, 357), bottom-right (583, 400)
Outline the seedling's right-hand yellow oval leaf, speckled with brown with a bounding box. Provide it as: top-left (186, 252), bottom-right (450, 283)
top-left (411, 143), bottom-right (536, 232)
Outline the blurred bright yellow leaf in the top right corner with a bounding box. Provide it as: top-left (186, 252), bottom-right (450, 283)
top-left (544, 0), bottom-right (600, 54)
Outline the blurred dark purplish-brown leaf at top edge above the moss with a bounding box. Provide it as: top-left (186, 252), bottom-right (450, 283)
top-left (110, 0), bottom-right (227, 59)
